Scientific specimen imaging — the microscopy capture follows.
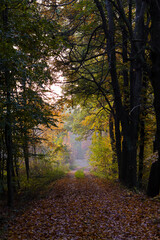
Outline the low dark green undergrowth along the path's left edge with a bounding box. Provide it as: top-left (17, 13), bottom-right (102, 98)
top-left (0, 168), bottom-right (66, 240)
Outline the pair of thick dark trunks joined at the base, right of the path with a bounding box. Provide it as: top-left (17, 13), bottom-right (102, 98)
top-left (94, 0), bottom-right (146, 187)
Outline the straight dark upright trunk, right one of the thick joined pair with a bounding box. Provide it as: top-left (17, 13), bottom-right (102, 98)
top-left (128, 0), bottom-right (146, 188)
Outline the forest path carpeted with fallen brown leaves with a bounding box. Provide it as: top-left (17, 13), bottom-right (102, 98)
top-left (0, 172), bottom-right (160, 240)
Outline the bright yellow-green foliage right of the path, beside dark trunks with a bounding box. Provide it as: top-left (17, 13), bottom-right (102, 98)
top-left (65, 102), bottom-right (118, 178)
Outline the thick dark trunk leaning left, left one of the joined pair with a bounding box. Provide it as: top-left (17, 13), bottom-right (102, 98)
top-left (94, 0), bottom-right (137, 187)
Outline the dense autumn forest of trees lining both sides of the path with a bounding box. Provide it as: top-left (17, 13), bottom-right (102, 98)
top-left (0, 0), bottom-right (160, 209)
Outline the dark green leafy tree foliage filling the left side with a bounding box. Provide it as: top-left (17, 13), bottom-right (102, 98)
top-left (0, 0), bottom-right (65, 202)
